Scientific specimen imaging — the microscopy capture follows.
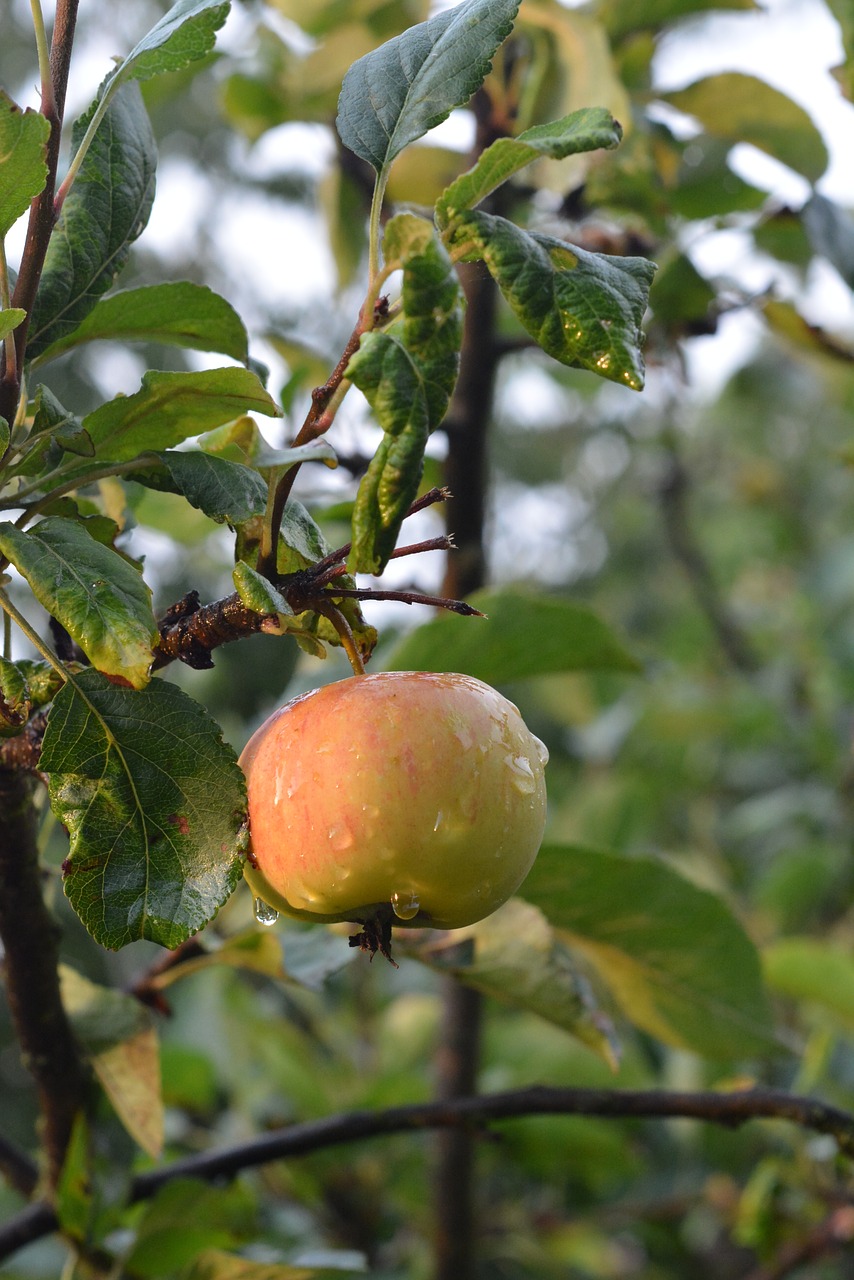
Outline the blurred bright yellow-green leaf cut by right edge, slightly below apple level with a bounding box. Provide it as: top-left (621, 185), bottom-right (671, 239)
top-left (762, 938), bottom-right (854, 1028)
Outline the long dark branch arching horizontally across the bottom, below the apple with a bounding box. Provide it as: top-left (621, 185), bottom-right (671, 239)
top-left (0, 1085), bottom-right (854, 1260)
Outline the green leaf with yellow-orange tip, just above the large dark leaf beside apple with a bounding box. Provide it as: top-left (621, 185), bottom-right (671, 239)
top-left (0, 516), bottom-right (157, 689)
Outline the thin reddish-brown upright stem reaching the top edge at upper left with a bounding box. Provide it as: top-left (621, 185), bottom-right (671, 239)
top-left (0, 0), bottom-right (79, 422)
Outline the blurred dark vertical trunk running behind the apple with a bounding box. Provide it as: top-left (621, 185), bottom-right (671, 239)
top-left (434, 90), bottom-right (501, 1280)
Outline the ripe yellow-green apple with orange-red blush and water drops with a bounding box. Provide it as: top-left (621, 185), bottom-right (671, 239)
top-left (241, 671), bottom-right (548, 929)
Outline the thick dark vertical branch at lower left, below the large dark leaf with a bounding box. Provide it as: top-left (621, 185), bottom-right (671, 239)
top-left (0, 769), bottom-right (86, 1185)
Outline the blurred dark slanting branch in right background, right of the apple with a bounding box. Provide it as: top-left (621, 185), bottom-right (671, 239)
top-left (659, 452), bottom-right (761, 675)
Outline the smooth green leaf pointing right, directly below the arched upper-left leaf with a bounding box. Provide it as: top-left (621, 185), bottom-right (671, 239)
top-left (83, 367), bottom-right (282, 462)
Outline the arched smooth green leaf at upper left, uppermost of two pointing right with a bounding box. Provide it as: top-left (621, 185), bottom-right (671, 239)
top-left (30, 280), bottom-right (248, 365)
